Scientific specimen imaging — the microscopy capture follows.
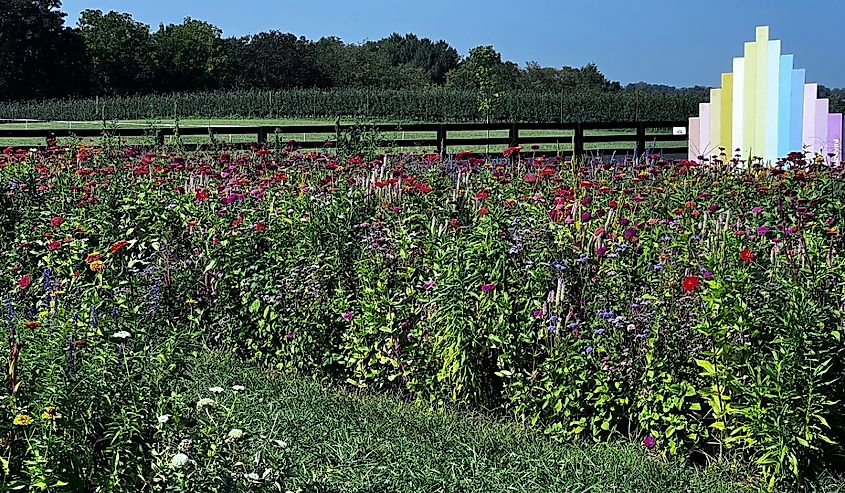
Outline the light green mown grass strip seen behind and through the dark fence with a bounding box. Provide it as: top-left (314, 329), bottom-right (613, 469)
top-left (0, 118), bottom-right (678, 152)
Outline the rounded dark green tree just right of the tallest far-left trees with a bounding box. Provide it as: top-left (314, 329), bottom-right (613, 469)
top-left (77, 10), bottom-right (154, 94)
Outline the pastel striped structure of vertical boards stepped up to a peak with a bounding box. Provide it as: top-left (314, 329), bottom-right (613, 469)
top-left (689, 27), bottom-right (843, 162)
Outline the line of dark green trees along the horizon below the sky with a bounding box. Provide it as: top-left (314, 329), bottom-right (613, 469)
top-left (0, 0), bottom-right (845, 116)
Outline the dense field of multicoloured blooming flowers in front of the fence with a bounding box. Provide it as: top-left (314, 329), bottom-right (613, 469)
top-left (0, 144), bottom-right (845, 490)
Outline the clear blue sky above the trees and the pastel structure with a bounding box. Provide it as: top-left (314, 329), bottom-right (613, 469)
top-left (62, 0), bottom-right (845, 87)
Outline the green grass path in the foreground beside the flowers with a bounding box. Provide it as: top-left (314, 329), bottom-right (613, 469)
top-left (166, 352), bottom-right (838, 493)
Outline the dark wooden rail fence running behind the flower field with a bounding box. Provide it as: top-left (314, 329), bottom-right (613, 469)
top-left (0, 121), bottom-right (689, 156)
